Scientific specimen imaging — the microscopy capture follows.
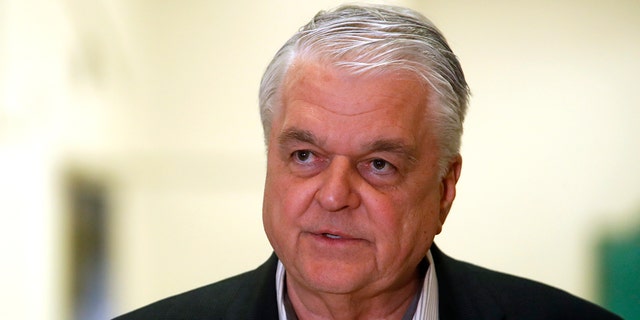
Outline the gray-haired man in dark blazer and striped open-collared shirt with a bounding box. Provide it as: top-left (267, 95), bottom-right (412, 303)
top-left (119, 6), bottom-right (617, 320)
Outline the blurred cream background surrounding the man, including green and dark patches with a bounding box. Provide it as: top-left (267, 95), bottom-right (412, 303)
top-left (0, 0), bottom-right (640, 319)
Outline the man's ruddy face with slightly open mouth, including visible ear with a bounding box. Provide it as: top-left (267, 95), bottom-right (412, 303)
top-left (263, 62), bottom-right (460, 293)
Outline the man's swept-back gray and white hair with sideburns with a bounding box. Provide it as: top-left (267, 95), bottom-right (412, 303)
top-left (259, 5), bottom-right (469, 174)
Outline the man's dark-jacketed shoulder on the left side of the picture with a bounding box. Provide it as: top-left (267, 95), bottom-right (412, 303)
top-left (114, 256), bottom-right (277, 320)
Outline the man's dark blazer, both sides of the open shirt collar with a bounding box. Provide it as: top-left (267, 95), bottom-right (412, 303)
top-left (116, 245), bottom-right (620, 320)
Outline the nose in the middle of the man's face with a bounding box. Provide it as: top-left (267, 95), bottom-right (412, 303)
top-left (316, 157), bottom-right (360, 212)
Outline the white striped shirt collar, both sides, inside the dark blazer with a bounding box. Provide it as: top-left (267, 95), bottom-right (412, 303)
top-left (276, 250), bottom-right (438, 320)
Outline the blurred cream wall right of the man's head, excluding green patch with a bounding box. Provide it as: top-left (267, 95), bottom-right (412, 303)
top-left (422, 1), bottom-right (640, 299)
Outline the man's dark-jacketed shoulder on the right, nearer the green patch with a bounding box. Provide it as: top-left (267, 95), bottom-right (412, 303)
top-left (434, 244), bottom-right (619, 319)
